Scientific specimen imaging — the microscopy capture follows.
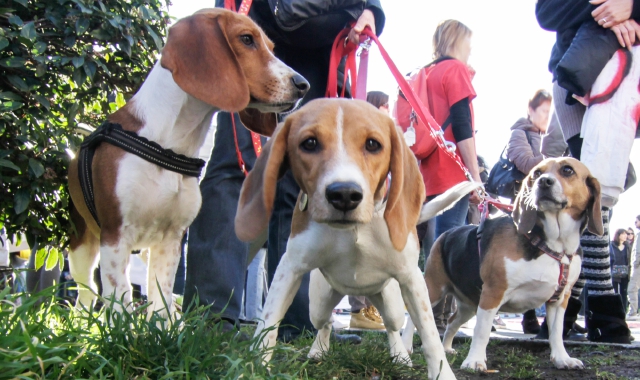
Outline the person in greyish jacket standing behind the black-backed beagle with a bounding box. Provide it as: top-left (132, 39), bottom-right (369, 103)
top-left (507, 90), bottom-right (552, 334)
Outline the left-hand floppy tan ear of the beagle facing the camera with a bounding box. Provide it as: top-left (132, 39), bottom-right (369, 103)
top-left (235, 115), bottom-right (294, 241)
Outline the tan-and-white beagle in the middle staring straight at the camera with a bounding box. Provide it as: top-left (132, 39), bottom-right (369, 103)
top-left (235, 99), bottom-right (477, 379)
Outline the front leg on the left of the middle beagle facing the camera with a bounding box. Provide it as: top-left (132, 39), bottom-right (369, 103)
top-left (253, 250), bottom-right (307, 365)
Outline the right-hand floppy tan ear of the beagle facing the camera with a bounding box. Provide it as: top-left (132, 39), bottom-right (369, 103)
top-left (384, 119), bottom-right (425, 251)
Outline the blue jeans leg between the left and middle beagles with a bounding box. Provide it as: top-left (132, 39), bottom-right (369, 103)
top-left (184, 112), bottom-right (264, 320)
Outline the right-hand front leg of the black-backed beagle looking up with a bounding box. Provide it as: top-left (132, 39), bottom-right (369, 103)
top-left (547, 296), bottom-right (584, 369)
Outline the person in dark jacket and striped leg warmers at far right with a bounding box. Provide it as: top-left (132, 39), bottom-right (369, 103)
top-left (535, 0), bottom-right (640, 344)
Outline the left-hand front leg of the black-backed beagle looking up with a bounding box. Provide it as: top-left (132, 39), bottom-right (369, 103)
top-left (460, 289), bottom-right (504, 371)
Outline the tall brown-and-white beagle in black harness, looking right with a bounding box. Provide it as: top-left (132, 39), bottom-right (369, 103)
top-left (69, 8), bottom-right (309, 316)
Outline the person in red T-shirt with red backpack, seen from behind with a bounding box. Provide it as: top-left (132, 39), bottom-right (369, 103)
top-left (396, 20), bottom-right (482, 331)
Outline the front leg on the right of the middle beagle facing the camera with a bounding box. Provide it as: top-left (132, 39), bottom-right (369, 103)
top-left (399, 266), bottom-right (455, 380)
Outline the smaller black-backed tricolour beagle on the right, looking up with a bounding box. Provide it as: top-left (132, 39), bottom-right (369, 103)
top-left (403, 157), bottom-right (603, 371)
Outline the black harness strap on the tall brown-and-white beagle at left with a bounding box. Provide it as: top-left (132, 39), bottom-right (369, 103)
top-left (78, 121), bottom-right (205, 226)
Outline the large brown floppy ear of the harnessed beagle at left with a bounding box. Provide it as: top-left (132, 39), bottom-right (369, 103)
top-left (160, 12), bottom-right (249, 112)
